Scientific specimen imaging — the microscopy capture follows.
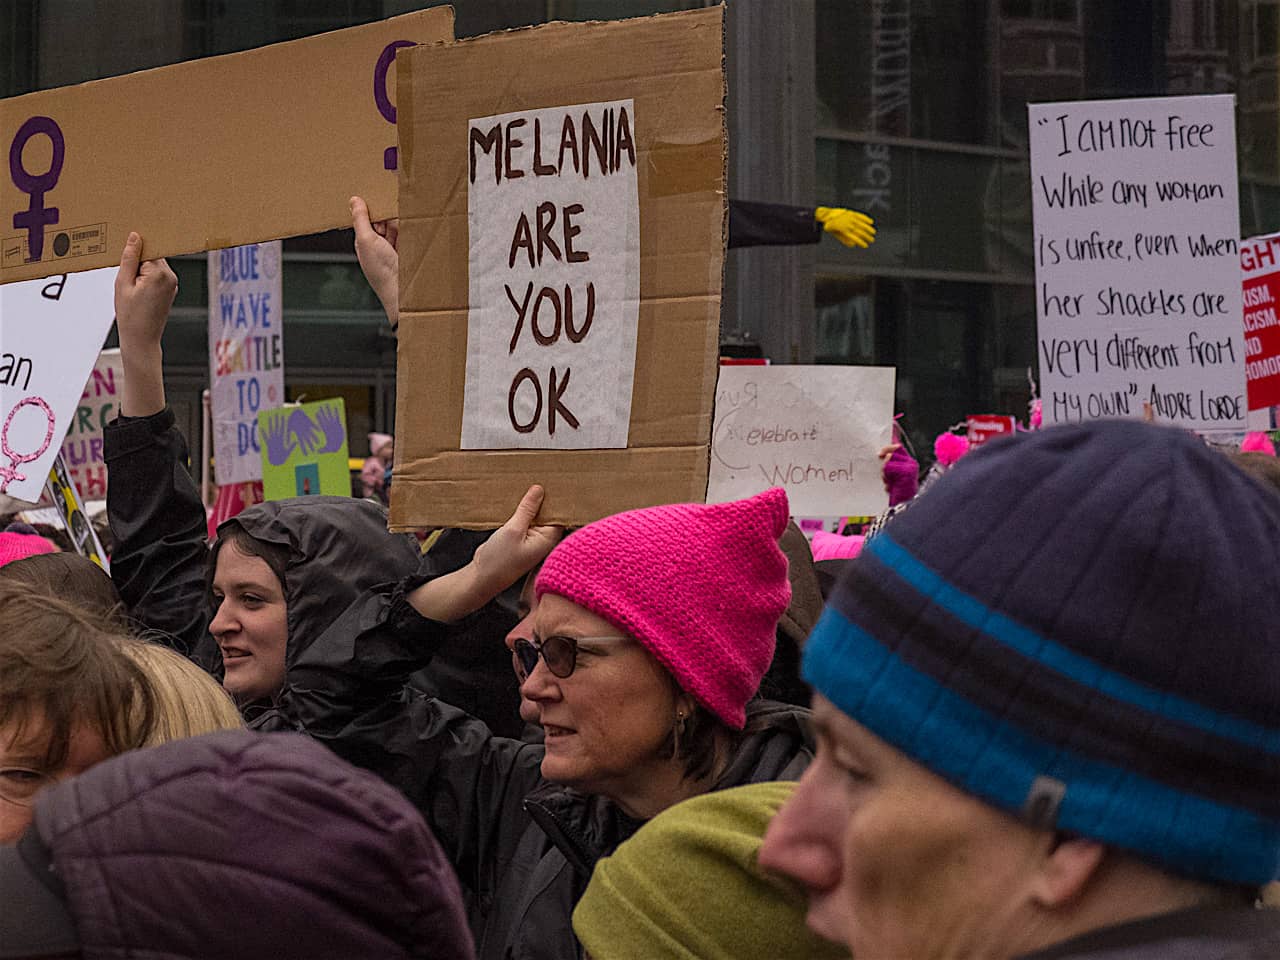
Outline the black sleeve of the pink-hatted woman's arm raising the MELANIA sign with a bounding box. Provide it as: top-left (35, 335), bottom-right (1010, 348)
top-left (272, 573), bottom-right (543, 901)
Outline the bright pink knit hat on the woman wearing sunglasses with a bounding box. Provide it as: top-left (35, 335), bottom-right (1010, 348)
top-left (535, 488), bottom-right (791, 730)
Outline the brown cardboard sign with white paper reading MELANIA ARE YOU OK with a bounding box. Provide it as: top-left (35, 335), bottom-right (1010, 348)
top-left (390, 6), bottom-right (726, 530)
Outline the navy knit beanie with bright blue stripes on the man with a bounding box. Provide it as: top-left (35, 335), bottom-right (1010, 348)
top-left (803, 421), bottom-right (1280, 884)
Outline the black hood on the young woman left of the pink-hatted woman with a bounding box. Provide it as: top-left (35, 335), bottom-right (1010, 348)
top-left (218, 497), bottom-right (421, 663)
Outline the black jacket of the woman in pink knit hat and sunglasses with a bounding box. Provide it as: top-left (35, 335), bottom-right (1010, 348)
top-left (264, 585), bottom-right (812, 960)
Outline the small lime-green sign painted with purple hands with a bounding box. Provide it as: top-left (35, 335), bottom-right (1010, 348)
top-left (257, 397), bottom-right (351, 500)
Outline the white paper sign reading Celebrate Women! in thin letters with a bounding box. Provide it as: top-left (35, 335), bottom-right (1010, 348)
top-left (707, 366), bottom-right (895, 517)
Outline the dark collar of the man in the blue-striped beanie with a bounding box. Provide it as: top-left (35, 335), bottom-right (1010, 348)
top-left (1023, 906), bottom-right (1280, 960)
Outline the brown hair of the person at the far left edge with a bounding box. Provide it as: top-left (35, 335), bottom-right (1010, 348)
top-left (0, 580), bottom-right (155, 769)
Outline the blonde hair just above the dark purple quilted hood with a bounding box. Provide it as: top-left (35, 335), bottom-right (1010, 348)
top-left (124, 639), bottom-right (244, 746)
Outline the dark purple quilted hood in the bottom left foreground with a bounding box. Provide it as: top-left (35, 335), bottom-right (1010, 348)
top-left (16, 731), bottom-right (474, 960)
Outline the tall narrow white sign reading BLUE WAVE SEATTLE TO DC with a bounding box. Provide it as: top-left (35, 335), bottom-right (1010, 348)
top-left (209, 241), bottom-right (284, 485)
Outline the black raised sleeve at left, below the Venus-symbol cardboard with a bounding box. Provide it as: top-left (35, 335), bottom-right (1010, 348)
top-left (102, 407), bottom-right (221, 676)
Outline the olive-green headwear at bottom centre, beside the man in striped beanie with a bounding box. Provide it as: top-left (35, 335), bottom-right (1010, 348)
top-left (573, 783), bottom-right (849, 960)
